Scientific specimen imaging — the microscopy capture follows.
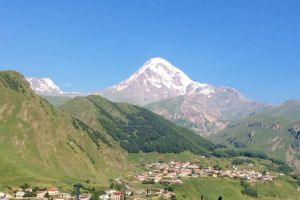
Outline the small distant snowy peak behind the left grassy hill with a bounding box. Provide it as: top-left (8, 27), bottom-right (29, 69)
top-left (26, 77), bottom-right (63, 95)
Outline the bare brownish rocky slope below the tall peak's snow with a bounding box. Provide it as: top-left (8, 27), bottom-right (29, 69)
top-left (145, 87), bottom-right (268, 137)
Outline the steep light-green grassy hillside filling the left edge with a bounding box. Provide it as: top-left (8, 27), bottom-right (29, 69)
top-left (0, 71), bottom-right (127, 188)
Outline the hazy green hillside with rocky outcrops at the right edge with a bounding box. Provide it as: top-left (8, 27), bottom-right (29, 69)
top-left (212, 101), bottom-right (300, 173)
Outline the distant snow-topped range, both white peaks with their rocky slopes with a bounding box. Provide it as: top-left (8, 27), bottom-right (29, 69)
top-left (27, 58), bottom-right (270, 136)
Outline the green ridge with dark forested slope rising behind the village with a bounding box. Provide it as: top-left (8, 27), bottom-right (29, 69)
top-left (62, 95), bottom-right (214, 154)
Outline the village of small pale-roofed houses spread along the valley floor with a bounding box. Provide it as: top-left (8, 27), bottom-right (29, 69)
top-left (0, 161), bottom-right (276, 200)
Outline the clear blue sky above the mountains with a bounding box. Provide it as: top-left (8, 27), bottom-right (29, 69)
top-left (0, 0), bottom-right (300, 103)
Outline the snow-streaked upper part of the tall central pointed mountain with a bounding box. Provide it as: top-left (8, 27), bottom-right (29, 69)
top-left (100, 58), bottom-right (214, 105)
